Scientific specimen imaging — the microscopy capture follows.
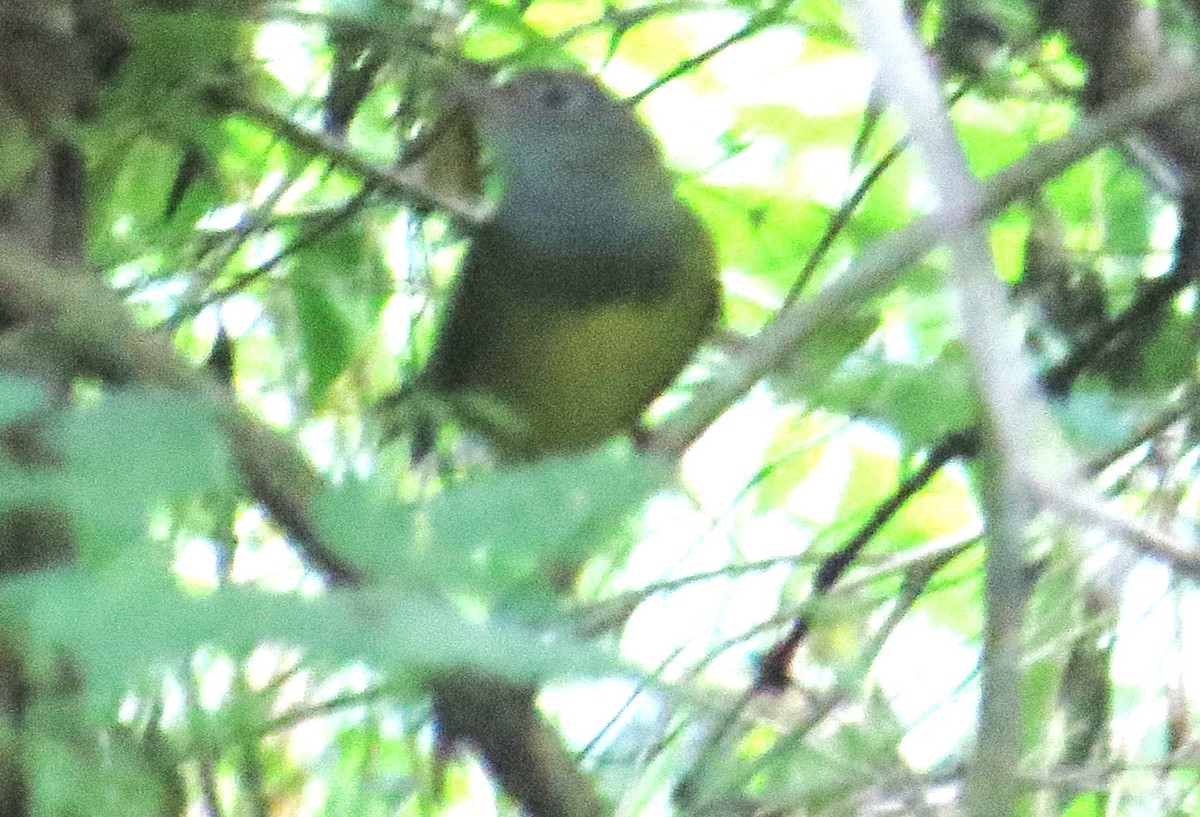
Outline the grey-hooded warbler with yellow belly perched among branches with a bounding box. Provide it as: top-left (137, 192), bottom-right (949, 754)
top-left (398, 70), bottom-right (720, 461)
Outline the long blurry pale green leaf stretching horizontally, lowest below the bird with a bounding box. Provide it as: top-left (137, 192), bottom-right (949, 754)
top-left (7, 564), bottom-right (623, 702)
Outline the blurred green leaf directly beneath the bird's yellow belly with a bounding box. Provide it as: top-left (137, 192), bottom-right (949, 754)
top-left (313, 451), bottom-right (667, 601)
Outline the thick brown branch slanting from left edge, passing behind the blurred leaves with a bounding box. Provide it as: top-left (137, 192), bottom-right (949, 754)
top-left (0, 238), bottom-right (602, 817)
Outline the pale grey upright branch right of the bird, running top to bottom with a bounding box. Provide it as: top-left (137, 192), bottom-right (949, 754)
top-left (850, 0), bottom-right (1036, 817)
